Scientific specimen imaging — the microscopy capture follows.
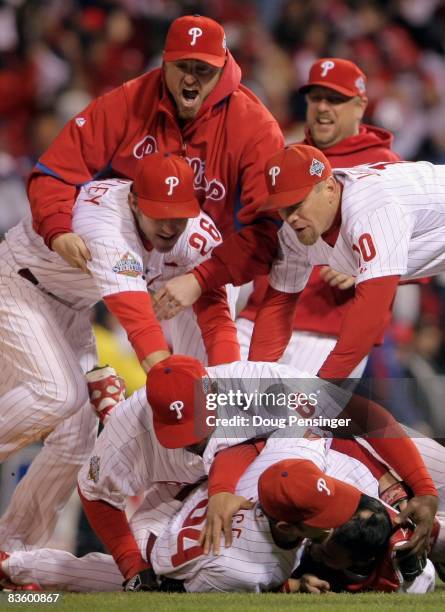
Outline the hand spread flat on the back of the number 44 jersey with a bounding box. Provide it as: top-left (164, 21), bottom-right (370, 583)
top-left (199, 493), bottom-right (254, 555)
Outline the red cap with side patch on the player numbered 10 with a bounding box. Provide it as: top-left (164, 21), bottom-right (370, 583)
top-left (261, 144), bottom-right (332, 210)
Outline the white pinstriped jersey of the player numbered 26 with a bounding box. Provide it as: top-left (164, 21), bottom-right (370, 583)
top-left (5, 179), bottom-right (221, 307)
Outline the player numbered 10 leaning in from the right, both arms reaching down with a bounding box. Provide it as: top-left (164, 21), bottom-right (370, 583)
top-left (249, 145), bottom-right (445, 378)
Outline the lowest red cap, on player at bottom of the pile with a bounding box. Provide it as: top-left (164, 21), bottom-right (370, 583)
top-left (258, 459), bottom-right (361, 529)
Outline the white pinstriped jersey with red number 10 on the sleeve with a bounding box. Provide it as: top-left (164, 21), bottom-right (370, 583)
top-left (270, 162), bottom-right (445, 293)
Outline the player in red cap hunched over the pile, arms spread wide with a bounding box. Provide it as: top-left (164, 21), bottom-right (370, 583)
top-left (72, 355), bottom-right (438, 580)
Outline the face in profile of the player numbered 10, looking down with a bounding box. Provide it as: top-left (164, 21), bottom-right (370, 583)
top-left (278, 177), bottom-right (335, 246)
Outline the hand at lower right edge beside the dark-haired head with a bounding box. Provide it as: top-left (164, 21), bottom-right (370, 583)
top-left (394, 495), bottom-right (438, 556)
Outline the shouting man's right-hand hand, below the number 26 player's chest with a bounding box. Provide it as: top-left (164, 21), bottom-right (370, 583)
top-left (153, 274), bottom-right (202, 321)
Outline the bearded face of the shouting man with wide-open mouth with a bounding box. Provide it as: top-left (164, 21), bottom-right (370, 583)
top-left (164, 60), bottom-right (222, 121)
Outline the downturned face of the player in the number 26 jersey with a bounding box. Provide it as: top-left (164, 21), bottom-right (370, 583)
top-left (129, 193), bottom-right (188, 253)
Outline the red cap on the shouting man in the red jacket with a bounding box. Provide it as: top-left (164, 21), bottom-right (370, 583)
top-left (163, 15), bottom-right (227, 68)
